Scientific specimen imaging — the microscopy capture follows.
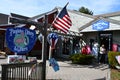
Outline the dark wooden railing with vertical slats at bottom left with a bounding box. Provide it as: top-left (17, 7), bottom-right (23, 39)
top-left (1, 63), bottom-right (42, 80)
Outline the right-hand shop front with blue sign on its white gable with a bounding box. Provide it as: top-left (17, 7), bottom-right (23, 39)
top-left (80, 12), bottom-right (120, 51)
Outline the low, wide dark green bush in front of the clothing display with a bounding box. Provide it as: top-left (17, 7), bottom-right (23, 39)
top-left (70, 53), bottom-right (94, 64)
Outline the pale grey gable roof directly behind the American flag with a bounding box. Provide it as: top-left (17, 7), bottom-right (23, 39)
top-left (30, 7), bottom-right (96, 34)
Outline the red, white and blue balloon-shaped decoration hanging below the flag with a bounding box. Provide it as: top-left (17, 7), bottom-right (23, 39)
top-left (47, 33), bottom-right (58, 49)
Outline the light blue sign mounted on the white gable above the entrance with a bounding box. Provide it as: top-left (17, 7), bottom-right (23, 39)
top-left (92, 20), bottom-right (109, 30)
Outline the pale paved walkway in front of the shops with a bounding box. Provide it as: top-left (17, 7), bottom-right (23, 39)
top-left (46, 61), bottom-right (110, 80)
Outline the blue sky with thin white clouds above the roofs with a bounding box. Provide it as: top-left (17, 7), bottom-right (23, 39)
top-left (0, 0), bottom-right (120, 17)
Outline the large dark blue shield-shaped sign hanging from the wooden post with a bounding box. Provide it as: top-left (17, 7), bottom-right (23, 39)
top-left (6, 27), bottom-right (36, 54)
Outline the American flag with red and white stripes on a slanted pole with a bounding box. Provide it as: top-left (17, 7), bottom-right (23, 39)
top-left (52, 5), bottom-right (72, 33)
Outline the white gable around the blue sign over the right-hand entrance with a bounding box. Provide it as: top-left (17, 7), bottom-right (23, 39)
top-left (79, 12), bottom-right (120, 32)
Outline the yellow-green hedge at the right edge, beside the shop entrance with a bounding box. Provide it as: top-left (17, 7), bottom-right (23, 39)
top-left (108, 51), bottom-right (120, 68)
